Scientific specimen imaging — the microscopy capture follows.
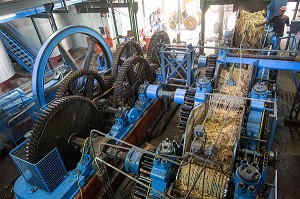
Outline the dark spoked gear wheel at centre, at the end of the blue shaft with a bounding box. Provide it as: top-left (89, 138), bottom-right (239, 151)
top-left (114, 56), bottom-right (154, 107)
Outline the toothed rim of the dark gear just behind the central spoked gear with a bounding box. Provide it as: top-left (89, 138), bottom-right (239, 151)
top-left (112, 41), bottom-right (143, 78)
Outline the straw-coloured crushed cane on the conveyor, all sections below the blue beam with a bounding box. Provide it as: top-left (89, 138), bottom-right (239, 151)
top-left (176, 66), bottom-right (252, 199)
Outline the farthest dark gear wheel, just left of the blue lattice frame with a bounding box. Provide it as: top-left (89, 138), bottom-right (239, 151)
top-left (147, 31), bottom-right (170, 66)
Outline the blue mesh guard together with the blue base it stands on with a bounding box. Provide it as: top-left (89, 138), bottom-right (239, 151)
top-left (10, 140), bottom-right (95, 199)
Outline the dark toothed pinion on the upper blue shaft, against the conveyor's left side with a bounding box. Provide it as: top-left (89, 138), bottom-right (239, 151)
top-left (178, 89), bottom-right (196, 131)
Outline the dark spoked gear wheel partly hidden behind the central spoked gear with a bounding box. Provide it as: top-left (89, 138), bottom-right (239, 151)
top-left (112, 41), bottom-right (143, 77)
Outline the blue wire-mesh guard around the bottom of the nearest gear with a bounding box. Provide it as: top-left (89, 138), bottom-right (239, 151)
top-left (9, 139), bottom-right (68, 193)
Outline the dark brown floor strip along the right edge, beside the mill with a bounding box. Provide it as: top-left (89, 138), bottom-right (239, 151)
top-left (273, 71), bottom-right (300, 199)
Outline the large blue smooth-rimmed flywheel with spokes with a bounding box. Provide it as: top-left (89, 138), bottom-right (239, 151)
top-left (32, 25), bottom-right (112, 108)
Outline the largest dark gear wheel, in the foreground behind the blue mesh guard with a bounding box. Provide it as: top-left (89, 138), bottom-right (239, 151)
top-left (26, 96), bottom-right (101, 171)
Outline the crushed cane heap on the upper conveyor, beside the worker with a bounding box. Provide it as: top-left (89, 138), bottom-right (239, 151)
top-left (234, 10), bottom-right (266, 48)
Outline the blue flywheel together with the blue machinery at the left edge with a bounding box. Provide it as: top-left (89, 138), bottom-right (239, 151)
top-left (0, 26), bottom-right (112, 148)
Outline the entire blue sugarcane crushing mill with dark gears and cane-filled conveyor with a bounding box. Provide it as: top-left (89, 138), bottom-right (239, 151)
top-left (10, 25), bottom-right (296, 199)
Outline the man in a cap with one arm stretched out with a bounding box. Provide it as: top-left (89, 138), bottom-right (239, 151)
top-left (255, 6), bottom-right (290, 50)
